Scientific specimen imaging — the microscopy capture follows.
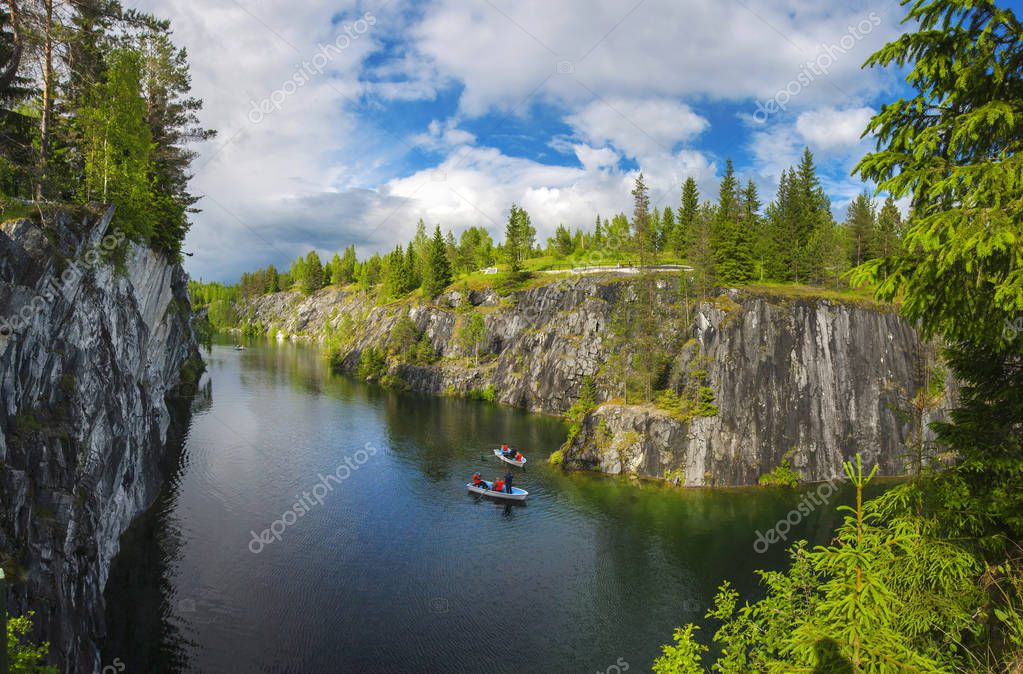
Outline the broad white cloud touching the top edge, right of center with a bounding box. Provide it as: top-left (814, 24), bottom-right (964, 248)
top-left (403, 0), bottom-right (900, 116)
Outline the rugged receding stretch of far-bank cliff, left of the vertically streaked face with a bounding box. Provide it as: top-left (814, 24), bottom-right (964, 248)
top-left (241, 279), bottom-right (609, 414)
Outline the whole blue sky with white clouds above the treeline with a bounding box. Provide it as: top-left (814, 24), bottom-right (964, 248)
top-left (136, 0), bottom-right (957, 280)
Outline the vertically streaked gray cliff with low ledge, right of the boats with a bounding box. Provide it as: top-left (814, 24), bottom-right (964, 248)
top-left (565, 295), bottom-right (954, 486)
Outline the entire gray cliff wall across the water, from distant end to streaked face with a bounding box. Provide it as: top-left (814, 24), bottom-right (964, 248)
top-left (243, 277), bottom-right (941, 485)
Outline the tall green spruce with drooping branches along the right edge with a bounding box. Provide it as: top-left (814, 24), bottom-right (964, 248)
top-left (853, 0), bottom-right (1023, 551)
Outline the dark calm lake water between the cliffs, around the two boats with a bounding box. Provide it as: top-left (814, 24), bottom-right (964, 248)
top-left (103, 342), bottom-right (855, 673)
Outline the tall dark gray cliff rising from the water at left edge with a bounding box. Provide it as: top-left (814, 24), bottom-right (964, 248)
top-left (0, 209), bottom-right (202, 672)
